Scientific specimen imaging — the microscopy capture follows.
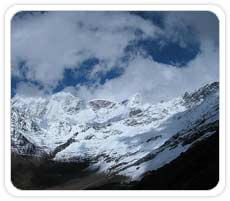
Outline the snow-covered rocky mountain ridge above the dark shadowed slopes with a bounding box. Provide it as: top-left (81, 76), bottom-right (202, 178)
top-left (11, 82), bottom-right (219, 180)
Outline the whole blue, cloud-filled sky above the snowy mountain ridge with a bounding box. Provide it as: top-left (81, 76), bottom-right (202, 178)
top-left (11, 11), bottom-right (219, 101)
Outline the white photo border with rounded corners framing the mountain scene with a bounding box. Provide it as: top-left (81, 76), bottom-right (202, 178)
top-left (4, 5), bottom-right (226, 197)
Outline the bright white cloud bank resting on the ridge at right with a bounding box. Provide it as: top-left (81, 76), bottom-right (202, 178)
top-left (78, 39), bottom-right (219, 102)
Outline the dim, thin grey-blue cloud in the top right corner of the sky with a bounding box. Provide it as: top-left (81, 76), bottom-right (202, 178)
top-left (165, 11), bottom-right (219, 48)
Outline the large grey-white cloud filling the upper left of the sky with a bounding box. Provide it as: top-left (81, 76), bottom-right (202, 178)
top-left (11, 12), bottom-right (160, 87)
